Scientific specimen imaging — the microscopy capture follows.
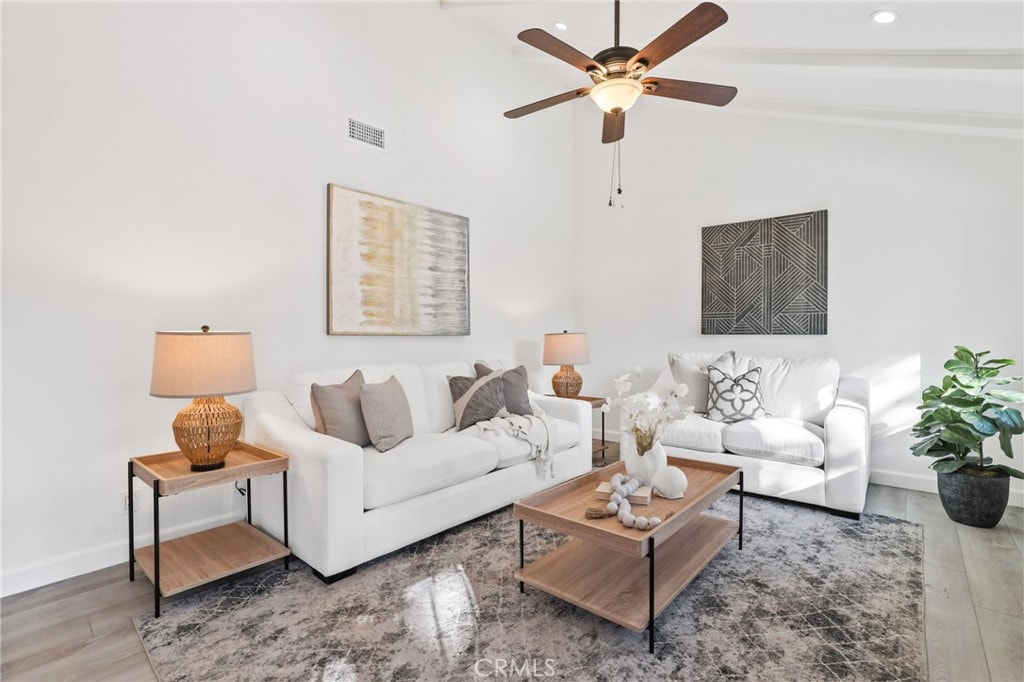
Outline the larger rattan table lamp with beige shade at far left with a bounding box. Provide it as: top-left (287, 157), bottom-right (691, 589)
top-left (150, 326), bottom-right (256, 471)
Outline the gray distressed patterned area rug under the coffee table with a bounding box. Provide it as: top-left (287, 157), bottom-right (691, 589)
top-left (135, 495), bottom-right (927, 682)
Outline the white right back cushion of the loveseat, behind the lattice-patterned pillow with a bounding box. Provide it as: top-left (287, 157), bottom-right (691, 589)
top-left (716, 355), bottom-right (840, 426)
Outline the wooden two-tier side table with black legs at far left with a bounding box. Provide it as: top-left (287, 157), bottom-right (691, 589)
top-left (128, 440), bottom-right (292, 617)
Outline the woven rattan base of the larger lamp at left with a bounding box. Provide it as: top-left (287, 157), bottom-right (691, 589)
top-left (171, 396), bottom-right (242, 471)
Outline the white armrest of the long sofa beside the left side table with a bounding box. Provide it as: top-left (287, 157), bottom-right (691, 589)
top-left (246, 391), bottom-right (364, 576)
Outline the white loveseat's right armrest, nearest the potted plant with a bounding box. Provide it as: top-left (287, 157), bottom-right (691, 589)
top-left (824, 377), bottom-right (871, 514)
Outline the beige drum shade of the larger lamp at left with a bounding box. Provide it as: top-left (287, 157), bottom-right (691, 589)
top-left (150, 332), bottom-right (256, 397)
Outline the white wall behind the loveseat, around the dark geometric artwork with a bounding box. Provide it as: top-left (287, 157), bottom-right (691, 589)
top-left (574, 103), bottom-right (1024, 505)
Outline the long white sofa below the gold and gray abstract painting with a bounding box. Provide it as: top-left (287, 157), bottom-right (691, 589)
top-left (244, 363), bottom-right (592, 582)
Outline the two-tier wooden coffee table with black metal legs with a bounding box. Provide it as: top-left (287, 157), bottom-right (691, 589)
top-left (512, 457), bottom-right (743, 653)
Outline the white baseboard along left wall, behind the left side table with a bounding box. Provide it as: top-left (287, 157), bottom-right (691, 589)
top-left (0, 514), bottom-right (245, 597)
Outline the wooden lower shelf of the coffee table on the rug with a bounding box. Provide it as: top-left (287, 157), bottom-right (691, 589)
top-left (515, 514), bottom-right (739, 632)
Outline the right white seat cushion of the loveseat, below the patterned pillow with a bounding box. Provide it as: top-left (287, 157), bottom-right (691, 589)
top-left (722, 418), bottom-right (825, 467)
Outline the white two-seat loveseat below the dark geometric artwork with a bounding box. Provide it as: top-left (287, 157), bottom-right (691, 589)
top-left (648, 351), bottom-right (870, 517)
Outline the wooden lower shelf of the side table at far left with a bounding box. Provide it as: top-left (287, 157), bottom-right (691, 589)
top-left (135, 521), bottom-right (291, 597)
